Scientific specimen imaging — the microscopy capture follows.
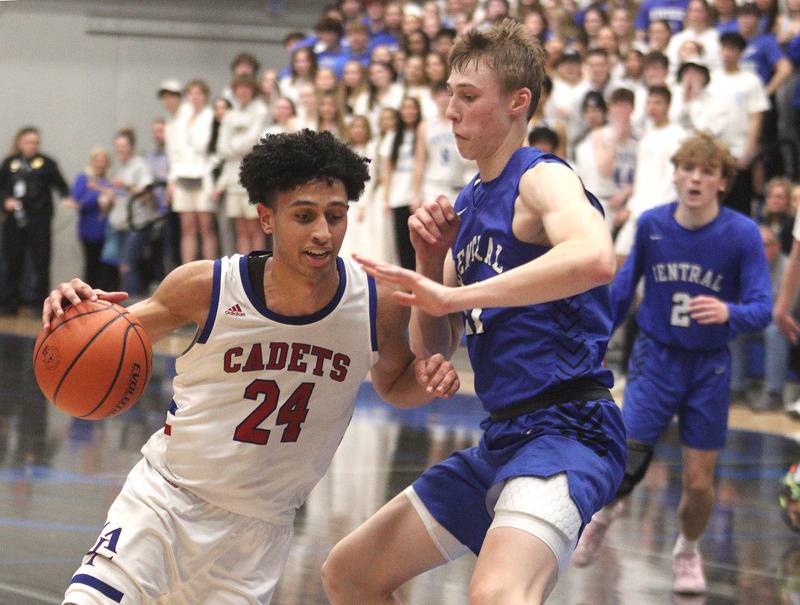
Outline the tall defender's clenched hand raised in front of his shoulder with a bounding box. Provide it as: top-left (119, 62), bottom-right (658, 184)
top-left (408, 195), bottom-right (461, 263)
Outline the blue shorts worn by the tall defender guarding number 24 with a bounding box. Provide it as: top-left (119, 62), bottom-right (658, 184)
top-left (413, 400), bottom-right (626, 555)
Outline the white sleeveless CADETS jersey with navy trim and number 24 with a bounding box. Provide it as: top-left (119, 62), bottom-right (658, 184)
top-left (142, 255), bottom-right (378, 523)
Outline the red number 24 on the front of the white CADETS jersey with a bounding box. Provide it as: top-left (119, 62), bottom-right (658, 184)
top-left (233, 378), bottom-right (314, 445)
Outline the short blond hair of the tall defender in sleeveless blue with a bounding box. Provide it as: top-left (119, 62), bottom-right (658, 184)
top-left (449, 18), bottom-right (545, 120)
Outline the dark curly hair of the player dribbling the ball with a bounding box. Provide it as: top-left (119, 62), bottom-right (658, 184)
top-left (239, 128), bottom-right (369, 206)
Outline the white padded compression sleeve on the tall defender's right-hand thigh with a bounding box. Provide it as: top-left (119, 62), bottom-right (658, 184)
top-left (489, 473), bottom-right (583, 576)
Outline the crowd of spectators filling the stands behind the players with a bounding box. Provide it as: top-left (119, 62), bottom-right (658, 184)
top-left (0, 0), bottom-right (800, 408)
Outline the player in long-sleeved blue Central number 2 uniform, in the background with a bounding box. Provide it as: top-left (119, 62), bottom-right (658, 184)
top-left (575, 133), bottom-right (772, 593)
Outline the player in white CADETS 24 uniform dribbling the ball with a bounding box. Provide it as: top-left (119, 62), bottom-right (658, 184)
top-left (43, 130), bottom-right (459, 605)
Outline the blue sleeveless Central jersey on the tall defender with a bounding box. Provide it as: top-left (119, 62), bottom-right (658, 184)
top-left (452, 147), bottom-right (613, 412)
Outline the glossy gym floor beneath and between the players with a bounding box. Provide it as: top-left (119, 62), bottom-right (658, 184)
top-left (0, 314), bottom-right (800, 605)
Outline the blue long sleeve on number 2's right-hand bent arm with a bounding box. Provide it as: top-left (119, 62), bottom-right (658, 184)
top-left (728, 225), bottom-right (772, 334)
